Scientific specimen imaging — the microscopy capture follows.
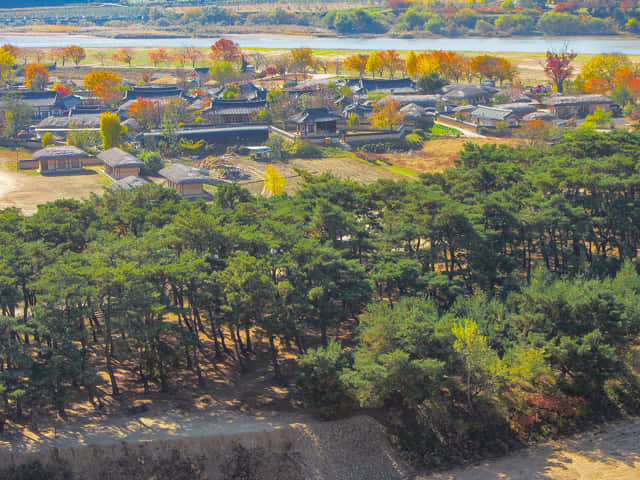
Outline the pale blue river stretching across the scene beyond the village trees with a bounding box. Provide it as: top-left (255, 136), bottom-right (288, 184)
top-left (0, 35), bottom-right (640, 55)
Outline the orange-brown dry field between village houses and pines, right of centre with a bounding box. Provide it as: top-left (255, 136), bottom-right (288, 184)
top-left (384, 137), bottom-right (522, 173)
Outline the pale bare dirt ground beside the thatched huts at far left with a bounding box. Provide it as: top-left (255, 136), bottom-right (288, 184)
top-left (0, 151), bottom-right (111, 214)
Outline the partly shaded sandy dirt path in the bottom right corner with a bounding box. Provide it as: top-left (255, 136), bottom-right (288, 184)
top-left (419, 418), bottom-right (640, 480)
